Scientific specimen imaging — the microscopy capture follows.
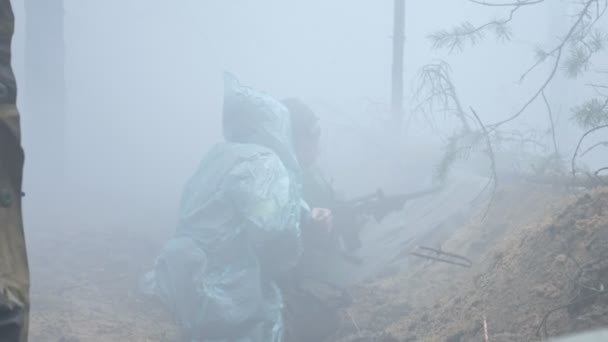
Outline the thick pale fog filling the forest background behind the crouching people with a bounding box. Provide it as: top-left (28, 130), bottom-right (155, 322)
top-left (8, 0), bottom-right (606, 340)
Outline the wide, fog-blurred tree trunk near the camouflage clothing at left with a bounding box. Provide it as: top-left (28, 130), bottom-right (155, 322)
top-left (24, 0), bottom-right (67, 177)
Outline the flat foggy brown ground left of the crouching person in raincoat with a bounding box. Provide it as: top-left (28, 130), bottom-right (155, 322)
top-left (25, 190), bottom-right (178, 342)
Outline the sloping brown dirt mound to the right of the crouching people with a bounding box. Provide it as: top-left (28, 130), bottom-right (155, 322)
top-left (332, 183), bottom-right (608, 342)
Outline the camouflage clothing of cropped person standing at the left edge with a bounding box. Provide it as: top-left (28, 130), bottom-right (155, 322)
top-left (0, 0), bottom-right (29, 342)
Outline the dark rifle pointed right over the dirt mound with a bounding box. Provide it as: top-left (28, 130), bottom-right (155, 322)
top-left (330, 186), bottom-right (442, 252)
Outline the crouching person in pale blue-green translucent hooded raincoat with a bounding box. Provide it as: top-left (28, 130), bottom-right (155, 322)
top-left (143, 75), bottom-right (329, 342)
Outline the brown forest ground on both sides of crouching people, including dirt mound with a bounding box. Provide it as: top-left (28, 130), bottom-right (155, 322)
top-left (26, 178), bottom-right (608, 342)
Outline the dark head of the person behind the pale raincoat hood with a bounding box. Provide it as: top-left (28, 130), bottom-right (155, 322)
top-left (282, 98), bottom-right (321, 167)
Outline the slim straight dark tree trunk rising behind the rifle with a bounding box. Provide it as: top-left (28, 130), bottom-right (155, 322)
top-left (391, 0), bottom-right (405, 124)
